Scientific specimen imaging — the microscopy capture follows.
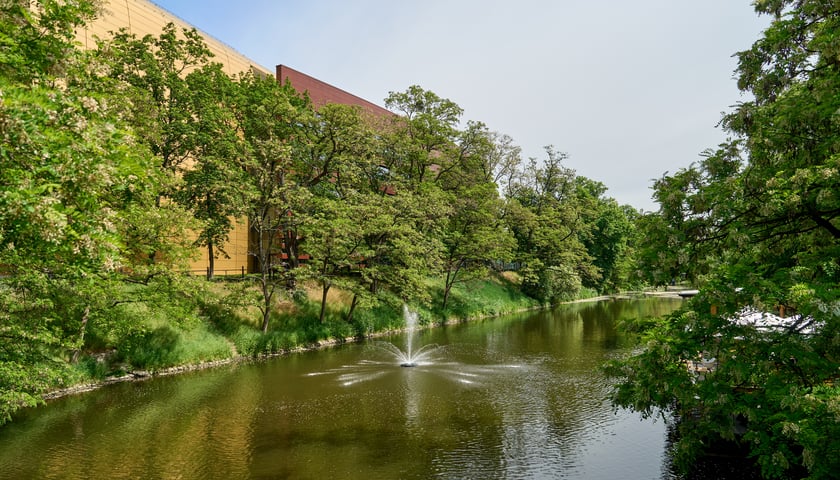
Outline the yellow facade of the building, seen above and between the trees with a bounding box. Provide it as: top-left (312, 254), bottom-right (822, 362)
top-left (77, 0), bottom-right (266, 275)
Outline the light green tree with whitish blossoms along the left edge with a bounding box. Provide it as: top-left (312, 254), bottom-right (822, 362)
top-left (0, 0), bottom-right (163, 423)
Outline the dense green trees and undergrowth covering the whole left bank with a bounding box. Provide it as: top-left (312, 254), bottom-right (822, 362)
top-left (0, 0), bottom-right (634, 423)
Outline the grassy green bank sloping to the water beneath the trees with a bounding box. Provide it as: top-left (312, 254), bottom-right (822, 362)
top-left (37, 274), bottom-right (539, 402)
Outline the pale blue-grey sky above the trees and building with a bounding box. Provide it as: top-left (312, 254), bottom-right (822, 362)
top-left (153, 0), bottom-right (769, 211)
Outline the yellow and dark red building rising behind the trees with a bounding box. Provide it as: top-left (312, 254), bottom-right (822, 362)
top-left (77, 0), bottom-right (392, 275)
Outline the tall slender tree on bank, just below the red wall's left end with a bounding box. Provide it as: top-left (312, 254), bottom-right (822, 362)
top-left (235, 73), bottom-right (312, 332)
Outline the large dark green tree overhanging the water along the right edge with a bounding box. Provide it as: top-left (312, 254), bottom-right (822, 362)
top-left (611, 0), bottom-right (840, 478)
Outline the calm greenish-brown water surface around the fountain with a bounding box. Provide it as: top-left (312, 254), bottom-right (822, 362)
top-left (0, 299), bottom-right (716, 480)
